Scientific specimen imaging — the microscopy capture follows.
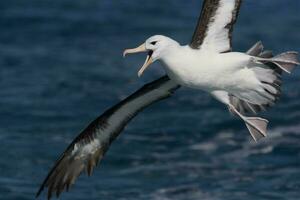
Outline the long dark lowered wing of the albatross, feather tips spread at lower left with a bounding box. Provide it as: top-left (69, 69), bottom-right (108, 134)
top-left (36, 76), bottom-right (179, 199)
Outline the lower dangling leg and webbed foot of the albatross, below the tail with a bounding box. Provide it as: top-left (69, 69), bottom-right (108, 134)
top-left (228, 104), bottom-right (269, 142)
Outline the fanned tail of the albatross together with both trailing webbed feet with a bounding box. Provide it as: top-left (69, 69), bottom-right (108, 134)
top-left (229, 42), bottom-right (299, 141)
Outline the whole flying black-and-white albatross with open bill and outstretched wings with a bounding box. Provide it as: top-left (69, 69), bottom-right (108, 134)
top-left (36, 0), bottom-right (299, 199)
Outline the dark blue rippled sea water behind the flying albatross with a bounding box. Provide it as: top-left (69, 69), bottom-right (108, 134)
top-left (0, 0), bottom-right (300, 200)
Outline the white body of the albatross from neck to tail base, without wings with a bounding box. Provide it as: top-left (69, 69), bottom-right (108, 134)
top-left (160, 45), bottom-right (260, 102)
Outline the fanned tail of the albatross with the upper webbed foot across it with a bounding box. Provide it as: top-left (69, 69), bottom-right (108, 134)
top-left (230, 42), bottom-right (299, 114)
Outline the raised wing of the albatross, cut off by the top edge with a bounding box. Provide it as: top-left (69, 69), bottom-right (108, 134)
top-left (190, 0), bottom-right (242, 53)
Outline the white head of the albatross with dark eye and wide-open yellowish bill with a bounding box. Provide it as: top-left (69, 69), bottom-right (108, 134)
top-left (123, 35), bottom-right (179, 77)
